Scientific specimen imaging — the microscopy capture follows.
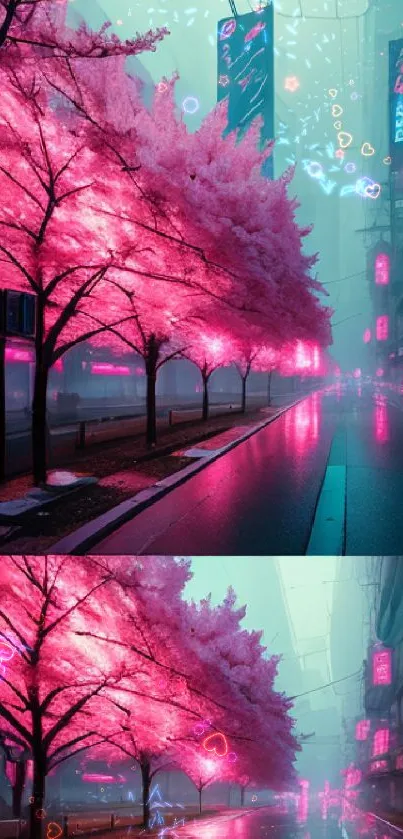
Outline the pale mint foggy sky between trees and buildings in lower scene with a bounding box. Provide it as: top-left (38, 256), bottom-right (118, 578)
top-left (186, 556), bottom-right (373, 790)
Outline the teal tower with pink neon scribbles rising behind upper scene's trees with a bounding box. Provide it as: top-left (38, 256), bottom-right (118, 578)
top-left (217, 2), bottom-right (274, 177)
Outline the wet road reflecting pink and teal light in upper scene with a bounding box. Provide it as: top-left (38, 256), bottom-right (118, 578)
top-left (91, 387), bottom-right (403, 556)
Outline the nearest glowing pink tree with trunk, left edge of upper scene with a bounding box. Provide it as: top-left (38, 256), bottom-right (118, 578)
top-left (0, 68), bottom-right (139, 483)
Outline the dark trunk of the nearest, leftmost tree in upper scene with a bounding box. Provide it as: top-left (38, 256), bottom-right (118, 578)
top-left (32, 300), bottom-right (49, 486)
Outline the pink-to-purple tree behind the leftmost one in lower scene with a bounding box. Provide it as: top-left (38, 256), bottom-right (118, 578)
top-left (78, 557), bottom-right (298, 825)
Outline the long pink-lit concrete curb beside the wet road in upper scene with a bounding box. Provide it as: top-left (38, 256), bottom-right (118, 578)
top-left (51, 393), bottom-right (312, 556)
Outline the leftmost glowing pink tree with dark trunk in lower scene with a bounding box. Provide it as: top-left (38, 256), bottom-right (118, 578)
top-left (0, 557), bottom-right (218, 839)
